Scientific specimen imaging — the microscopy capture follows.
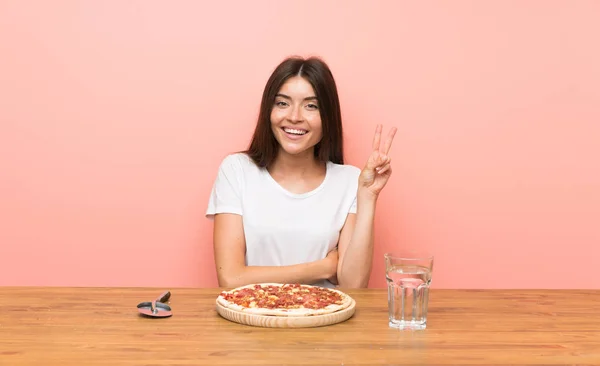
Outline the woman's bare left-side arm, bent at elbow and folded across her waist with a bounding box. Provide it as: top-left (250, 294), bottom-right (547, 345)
top-left (213, 214), bottom-right (338, 288)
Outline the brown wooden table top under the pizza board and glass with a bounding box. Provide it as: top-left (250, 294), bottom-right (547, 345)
top-left (0, 287), bottom-right (600, 366)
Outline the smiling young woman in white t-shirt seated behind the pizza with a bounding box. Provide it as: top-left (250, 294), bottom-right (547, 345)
top-left (206, 57), bottom-right (396, 288)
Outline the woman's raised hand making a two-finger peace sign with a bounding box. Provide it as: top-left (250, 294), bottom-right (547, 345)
top-left (358, 125), bottom-right (397, 198)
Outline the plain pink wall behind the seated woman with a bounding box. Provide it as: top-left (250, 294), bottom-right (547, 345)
top-left (0, 0), bottom-right (600, 288)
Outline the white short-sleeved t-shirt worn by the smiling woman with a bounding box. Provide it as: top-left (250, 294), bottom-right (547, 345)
top-left (206, 153), bottom-right (360, 287)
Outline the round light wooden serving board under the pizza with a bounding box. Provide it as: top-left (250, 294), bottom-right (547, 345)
top-left (216, 299), bottom-right (356, 328)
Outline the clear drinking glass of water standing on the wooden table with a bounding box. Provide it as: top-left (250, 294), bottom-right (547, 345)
top-left (384, 253), bottom-right (433, 330)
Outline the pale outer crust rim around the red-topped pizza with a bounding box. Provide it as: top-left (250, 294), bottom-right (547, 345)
top-left (217, 283), bottom-right (352, 317)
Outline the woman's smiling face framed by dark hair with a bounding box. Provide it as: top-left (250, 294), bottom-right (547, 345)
top-left (271, 76), bottom-right (323, 156)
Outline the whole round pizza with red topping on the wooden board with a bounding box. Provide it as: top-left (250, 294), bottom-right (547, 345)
top-left (217, 283), bottom-right (352, 316)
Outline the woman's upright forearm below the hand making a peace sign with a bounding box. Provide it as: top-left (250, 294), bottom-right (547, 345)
top-left (337, 193), bottom-right (377, 288)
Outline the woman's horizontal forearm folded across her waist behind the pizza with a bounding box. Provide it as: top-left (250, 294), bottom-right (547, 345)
top-left (219, 260), bottom-right (330, 287)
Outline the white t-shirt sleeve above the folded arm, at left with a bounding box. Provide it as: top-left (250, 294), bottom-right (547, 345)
top-left (206, 155), bottom-right (243, 218)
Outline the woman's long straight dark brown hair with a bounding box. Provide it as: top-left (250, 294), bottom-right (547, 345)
top-left (245, 56), bottom-right (344, 167)
